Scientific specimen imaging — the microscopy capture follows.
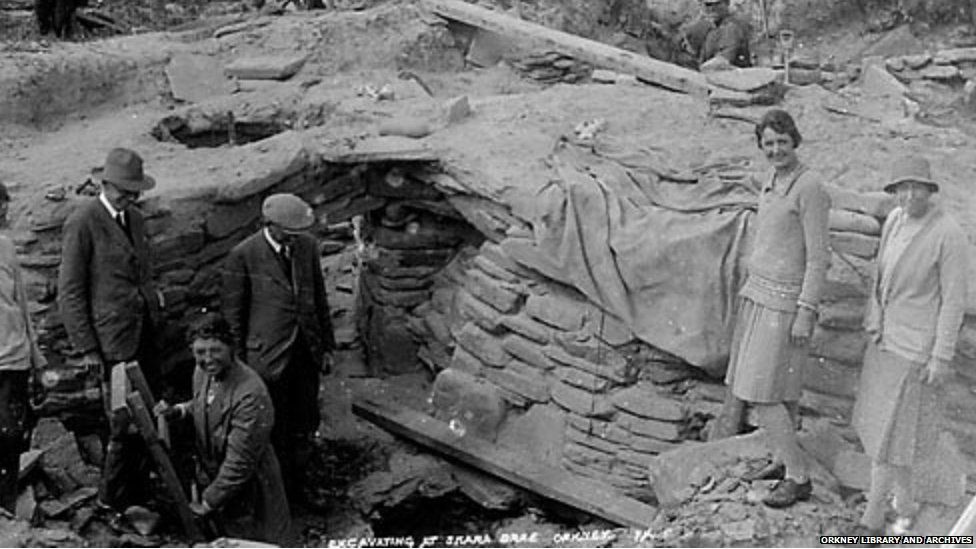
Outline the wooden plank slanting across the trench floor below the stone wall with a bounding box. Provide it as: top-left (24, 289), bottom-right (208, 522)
top-left (353, 398), bottom-right (657, 528)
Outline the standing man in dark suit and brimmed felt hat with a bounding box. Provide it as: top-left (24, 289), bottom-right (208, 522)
top-left (58, 148), bottom-right (159, 519)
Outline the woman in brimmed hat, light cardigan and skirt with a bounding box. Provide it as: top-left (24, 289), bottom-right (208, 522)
top-left (851, 155), bottom-right (968, 534)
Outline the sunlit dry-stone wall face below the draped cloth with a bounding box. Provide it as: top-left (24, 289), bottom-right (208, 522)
top-left (424, 242), bottom-right (716, 496)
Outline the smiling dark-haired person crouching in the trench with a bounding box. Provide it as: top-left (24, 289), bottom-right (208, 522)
top-left (155, 313), bottom-right (296, 547)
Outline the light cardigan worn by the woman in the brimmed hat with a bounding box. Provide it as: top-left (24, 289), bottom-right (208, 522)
top-left (864, 208), bottom-right (969, 362)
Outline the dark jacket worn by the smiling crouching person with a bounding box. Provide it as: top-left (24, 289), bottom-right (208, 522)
top-left (189, 363), bottom-right (291, 543)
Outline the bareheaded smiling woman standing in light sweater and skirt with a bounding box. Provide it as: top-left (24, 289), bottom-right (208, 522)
top-left (725, 109), bottom-right (830, 507)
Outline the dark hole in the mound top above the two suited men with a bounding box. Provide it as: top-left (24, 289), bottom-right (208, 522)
top-left (151, 113), bottom-right (288, 149)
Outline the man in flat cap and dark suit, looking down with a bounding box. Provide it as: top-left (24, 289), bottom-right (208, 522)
top-left (223, 194), bottom-right (335, 502)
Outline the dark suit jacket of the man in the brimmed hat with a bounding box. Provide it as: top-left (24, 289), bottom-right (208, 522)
top-left (58, 199), bottom-right (158, 362)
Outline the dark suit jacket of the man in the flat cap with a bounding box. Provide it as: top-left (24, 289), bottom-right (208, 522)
top-left (223, 229), bottom-right (335, 380)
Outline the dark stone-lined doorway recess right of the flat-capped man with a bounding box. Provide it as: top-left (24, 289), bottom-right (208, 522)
top-left (359, 167), bottom-right (484, 373)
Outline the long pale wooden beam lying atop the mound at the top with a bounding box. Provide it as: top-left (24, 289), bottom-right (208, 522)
top-left (424, 0), bottom-right (708, 96)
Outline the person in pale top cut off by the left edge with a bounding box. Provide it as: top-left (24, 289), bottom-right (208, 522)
top-left (0, 183), bottom-right (47, 513)
